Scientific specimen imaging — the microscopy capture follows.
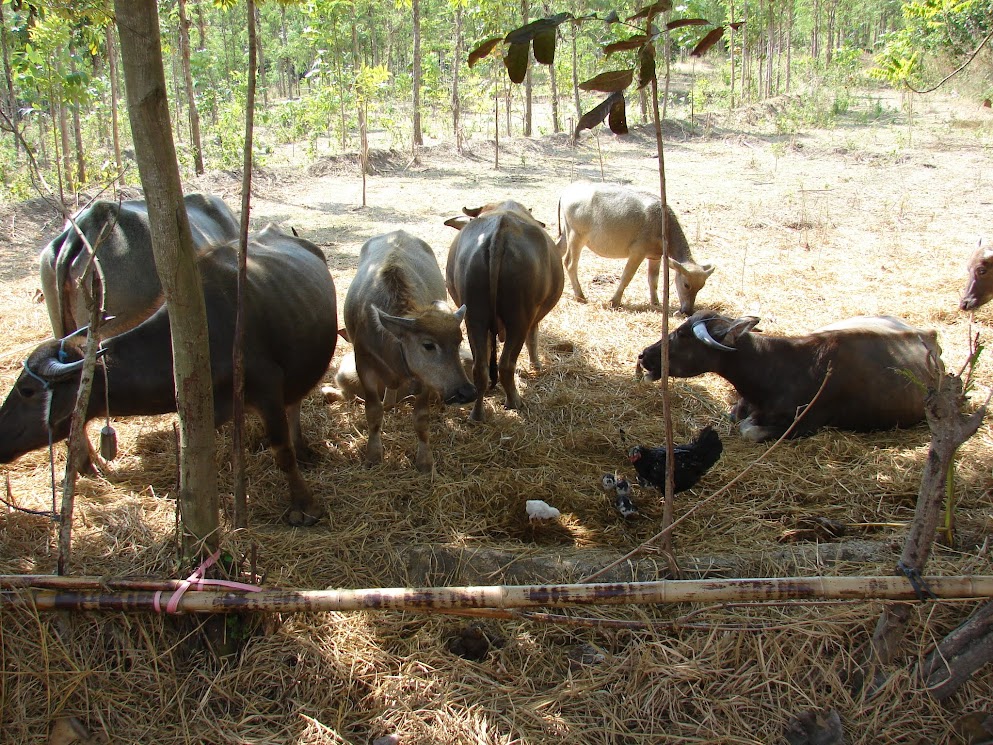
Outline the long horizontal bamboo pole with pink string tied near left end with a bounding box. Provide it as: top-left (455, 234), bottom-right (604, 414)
top-left (0, 576), bottom-right (993, 613)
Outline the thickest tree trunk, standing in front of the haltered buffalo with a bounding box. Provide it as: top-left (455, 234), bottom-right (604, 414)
top-left (114, 0), bottom-right (219, 560)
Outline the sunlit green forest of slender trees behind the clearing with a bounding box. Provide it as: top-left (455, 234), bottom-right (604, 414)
top-left (0, 0), bottom-right (993, 200)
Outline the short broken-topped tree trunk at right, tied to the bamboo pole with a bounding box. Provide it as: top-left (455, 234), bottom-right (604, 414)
top-left (872, 342), bottom-right (986, 664)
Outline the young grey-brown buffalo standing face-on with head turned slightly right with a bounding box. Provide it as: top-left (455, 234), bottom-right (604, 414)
top-left (344, 230), bottom-right (476, 472)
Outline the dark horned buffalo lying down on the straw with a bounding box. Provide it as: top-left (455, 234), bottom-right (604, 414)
top-left (638, 311), bottom-right (937, 442)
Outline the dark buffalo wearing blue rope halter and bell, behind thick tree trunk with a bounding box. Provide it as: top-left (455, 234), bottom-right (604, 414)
top-left (0, 225), bottom-right (338, 525)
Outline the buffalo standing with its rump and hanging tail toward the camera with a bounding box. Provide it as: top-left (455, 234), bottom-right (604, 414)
top-left (445, 201), bottom-right (565, 421)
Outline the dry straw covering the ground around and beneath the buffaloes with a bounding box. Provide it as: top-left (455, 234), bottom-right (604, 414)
top-left (0, 93), bottom-right (993, 743)
